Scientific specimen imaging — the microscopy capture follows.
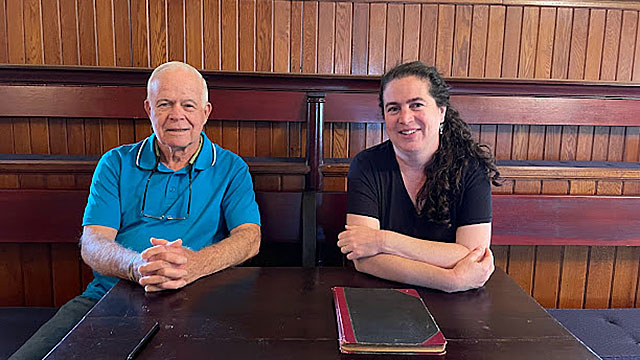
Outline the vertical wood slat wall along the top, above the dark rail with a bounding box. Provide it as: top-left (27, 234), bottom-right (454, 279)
top-left (0, 0), bottom-right (640, 81)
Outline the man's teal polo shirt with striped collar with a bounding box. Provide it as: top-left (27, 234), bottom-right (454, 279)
top-left (82, 133), bottom-right (260, 299)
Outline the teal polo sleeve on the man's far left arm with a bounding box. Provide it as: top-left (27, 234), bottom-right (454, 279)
top-left (82, 151), bottom-right (121, 230)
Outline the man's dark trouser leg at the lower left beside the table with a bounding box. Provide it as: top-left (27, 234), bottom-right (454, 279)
top-left (9, 296), bottom-right (98, 360)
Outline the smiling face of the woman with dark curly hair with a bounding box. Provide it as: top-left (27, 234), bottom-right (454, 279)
top-left (382, 76), bottom-right (447, 160)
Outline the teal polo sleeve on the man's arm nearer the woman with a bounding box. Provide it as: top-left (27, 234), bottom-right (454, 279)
top-left (222, 159), bottom-right (260, 231)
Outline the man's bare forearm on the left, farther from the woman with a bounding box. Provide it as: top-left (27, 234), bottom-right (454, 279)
top-left (80, 227), bottom-right (138, 279)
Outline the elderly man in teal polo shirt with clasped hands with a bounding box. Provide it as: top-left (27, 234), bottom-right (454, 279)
top-left (11, 62), bottom-right (260, 359)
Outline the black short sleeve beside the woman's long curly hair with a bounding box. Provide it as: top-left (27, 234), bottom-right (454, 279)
top-left (456, 162), bottom-right (491, 227)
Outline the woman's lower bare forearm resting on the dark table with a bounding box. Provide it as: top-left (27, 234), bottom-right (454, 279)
top-left (354, 254), bottom-right (459, 292)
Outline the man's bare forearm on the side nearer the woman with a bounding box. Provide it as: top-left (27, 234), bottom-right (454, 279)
top-left (188, 224), bottom-right (260, 282)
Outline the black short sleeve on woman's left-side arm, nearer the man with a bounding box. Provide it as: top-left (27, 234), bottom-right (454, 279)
top-left (347, 156), bottom-right (380, 219)
